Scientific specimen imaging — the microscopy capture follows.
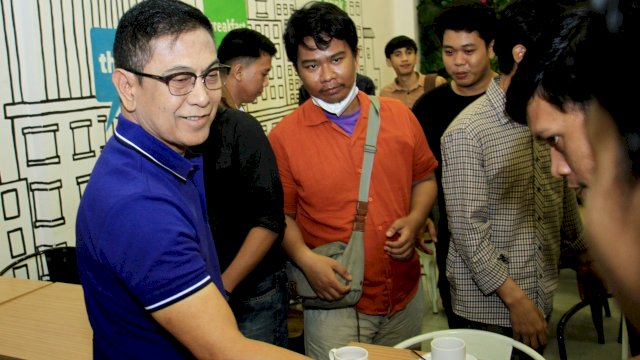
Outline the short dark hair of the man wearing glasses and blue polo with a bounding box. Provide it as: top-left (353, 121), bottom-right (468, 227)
top-left (113, 0), bottom-right (213, 71)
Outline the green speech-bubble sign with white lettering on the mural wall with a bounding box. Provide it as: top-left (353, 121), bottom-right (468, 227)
top-left (204, 0), bottom-right (247, 45)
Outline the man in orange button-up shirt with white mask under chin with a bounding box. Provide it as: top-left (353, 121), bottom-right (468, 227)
top-left (269, 3), bottom-right (437, 359)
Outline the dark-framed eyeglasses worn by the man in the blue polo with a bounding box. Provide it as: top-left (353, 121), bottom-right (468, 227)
top-left (124, 64), bottom-right (231, 96)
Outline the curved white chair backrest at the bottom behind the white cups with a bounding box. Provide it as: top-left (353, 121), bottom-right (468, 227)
top-left (394, 329), bottom-right (544, 360)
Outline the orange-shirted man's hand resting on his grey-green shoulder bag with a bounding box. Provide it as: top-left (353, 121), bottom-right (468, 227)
top-left (301, 252), bottom-right (351, 300)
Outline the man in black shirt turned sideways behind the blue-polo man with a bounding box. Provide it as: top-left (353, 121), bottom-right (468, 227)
top-left (192, 28), bottom-right (289, 347)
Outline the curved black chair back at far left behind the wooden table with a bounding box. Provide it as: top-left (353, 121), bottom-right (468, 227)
top-left (0, 246), bottom-right (80, 284)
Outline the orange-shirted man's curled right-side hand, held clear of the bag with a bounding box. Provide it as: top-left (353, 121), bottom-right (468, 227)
top-left (384, 216), bottom-right (422, 261)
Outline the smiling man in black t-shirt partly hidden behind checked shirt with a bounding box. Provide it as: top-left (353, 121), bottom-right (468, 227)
top-left (412, 1), bottom-right (497, 328)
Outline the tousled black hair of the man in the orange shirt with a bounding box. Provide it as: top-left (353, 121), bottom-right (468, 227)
top-left (283, 1), bottom-right (358, 69)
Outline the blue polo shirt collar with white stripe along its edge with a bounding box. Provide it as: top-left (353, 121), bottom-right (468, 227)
top-left (115, 114), bottom-right (196, 181)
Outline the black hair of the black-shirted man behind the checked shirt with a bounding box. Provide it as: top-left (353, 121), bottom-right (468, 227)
top-left (433, 0), bottom-right (497, 46)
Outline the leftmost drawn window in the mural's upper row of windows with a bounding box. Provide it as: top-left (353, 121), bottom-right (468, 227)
top-left (22, 124), bottom-right (60, 166)
